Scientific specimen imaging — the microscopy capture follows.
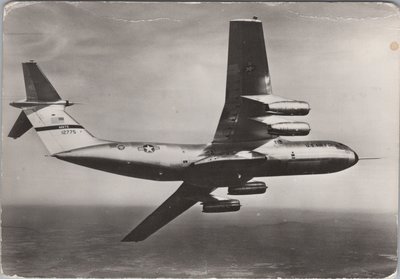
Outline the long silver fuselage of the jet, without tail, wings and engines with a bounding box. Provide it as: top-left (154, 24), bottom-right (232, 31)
top-left (54, 138), bottom-right (358, 187)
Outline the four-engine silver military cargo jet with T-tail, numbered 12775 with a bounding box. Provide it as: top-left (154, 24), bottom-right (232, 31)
top-left (9, 18), bottom-right (358, 242)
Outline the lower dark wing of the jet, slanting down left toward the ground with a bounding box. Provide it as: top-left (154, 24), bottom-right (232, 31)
top-left (122, 182), bottom-right (214, 242)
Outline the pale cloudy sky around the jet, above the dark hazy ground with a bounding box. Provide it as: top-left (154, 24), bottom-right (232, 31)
top-left (1, 2), bottom-right (400, 212)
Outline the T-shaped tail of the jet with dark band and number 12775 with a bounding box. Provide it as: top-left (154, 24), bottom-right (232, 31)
top-left (8, 61), bottom-right (104, 155)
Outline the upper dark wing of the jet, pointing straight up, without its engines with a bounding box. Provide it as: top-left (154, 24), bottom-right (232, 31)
top-left (213, 19), bottom-right (275, 144)
